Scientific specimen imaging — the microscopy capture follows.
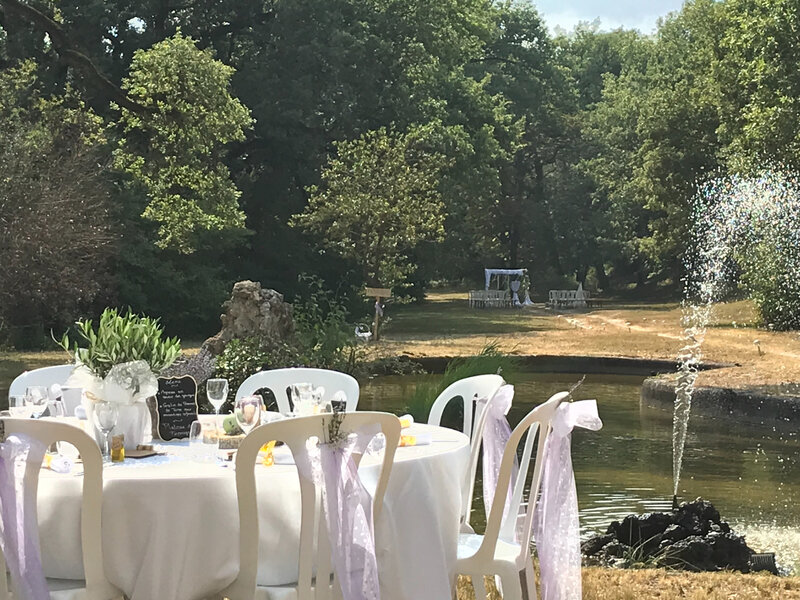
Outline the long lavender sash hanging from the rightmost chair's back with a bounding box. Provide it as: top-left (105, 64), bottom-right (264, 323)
top-left (533, 400), bottom-right (603, 600)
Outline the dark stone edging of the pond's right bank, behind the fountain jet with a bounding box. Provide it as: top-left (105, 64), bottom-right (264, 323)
top-left (642, 377), bottom-right (800, 424)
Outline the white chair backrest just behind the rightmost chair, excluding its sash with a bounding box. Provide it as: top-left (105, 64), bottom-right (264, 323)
top-left (428, 375), bottom-right (505, 531)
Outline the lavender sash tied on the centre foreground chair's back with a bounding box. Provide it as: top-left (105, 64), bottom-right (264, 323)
top-left (295, 425), bottom-right (380, 600)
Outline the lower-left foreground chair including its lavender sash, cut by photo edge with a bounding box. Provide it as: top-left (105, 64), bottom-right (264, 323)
top-left (0, 418), bottom-right (123, 600)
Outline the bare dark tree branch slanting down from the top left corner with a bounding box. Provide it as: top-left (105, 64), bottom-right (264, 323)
top-left (0, 0), bottom-right (149, 113)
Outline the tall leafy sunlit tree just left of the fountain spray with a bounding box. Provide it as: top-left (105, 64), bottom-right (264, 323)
top-left (587, 0), bottom-right (724, 283)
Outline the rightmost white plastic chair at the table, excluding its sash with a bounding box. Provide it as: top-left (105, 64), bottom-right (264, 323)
top-left (456, 392), bottom-right (569, 600)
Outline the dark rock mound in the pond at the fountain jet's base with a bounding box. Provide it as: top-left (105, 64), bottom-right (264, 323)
top-left (581, 498), bottom-right (753, 573)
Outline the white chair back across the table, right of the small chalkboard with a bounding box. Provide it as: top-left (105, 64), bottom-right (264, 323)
top-left (236, 367), bottom-right (359, 413)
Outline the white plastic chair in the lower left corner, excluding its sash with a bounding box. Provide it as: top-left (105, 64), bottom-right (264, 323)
top-left (0, 418), bottom-right (123, 600)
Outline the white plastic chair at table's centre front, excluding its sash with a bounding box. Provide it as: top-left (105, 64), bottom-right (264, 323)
top-left (222, 412), bottom-right (400, 600)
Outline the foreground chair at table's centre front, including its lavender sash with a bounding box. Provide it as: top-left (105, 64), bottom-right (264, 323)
top-left (222, 412), bottom-right (400, 600)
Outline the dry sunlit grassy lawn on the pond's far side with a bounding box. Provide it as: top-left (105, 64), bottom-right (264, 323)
top-left (380, 292), bottom-right (800, 387)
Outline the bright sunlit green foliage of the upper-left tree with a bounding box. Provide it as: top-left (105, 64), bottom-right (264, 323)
top-left (114, 32), bottom-right (251, 252)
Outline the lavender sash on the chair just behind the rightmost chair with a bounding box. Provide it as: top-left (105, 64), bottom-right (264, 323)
top-left (483, 385), bottom-right (519, 516)
